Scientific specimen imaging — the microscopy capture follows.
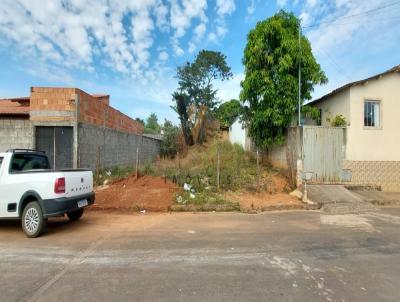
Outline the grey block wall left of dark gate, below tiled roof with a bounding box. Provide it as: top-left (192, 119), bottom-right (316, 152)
top-left (0, 118), bottom-right (34, 152)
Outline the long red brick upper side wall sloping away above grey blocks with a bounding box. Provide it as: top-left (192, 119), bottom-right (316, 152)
top-left (76, 89), bottom-right (143, 134)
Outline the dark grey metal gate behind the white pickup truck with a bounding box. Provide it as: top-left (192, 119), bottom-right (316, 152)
top-left (36, 127), bottom-right (73, 169)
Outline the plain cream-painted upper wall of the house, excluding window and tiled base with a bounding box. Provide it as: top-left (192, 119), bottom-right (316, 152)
top-left (315, 72), bottom-right (400, 161)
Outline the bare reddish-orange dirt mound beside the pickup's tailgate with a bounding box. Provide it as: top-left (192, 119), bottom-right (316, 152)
top-left (91, 175), bottom-right (179, 212)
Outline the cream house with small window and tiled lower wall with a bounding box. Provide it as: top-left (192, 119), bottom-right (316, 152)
top-left (310, 65), bottom-right (400, 191)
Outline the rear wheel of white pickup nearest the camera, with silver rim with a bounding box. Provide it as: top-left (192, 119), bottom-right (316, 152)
top-left (22, 201), bottom-right (47, 238)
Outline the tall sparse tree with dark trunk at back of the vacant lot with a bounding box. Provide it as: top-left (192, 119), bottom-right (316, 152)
top-left (173, 50), bottom-right (232, 145)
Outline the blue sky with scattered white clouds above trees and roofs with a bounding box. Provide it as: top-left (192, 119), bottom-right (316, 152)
top-left (0, 0), bottom-right (400, 121)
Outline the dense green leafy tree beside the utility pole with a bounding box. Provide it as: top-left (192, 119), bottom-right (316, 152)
top-left (240, 11), bottom-right (327, 148)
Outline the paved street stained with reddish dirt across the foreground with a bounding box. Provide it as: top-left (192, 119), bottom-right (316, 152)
top-left (0, 208), bottom-right (400, 302)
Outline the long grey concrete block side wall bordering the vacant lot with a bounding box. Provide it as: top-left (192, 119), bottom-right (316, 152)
top-left (78, 123), bottom-right (160, 170)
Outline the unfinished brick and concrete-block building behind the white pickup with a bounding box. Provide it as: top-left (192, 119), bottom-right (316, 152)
top-left (0, 87), bottom-right (160, 169)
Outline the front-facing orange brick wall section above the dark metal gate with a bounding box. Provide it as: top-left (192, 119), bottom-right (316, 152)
top-left (30, 87), bottom-right (75, 121)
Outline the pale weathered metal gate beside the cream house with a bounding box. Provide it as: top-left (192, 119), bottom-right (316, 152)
top-left (303, 126), bottom-right (345, 183)
